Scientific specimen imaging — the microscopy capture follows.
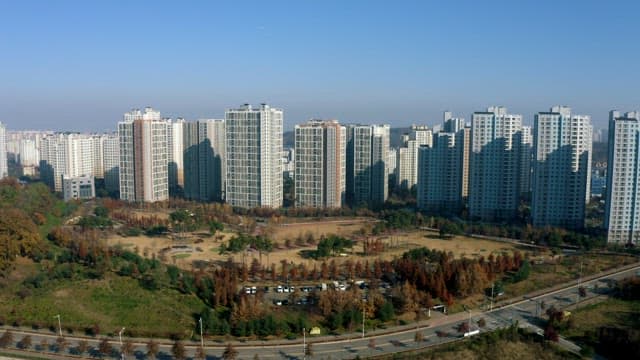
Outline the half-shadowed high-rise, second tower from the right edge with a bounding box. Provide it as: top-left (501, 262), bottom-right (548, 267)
top-left (531, 106), bottom-right (592, 229)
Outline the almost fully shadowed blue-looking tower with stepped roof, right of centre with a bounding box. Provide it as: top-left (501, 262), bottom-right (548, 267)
top-left (417, 130), bottom-right (464, 215)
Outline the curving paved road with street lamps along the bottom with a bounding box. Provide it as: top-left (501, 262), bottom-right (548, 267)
top-left (2, 265), bottom-right (640, 360)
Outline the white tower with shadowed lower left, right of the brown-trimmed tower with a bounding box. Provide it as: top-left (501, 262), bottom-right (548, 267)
top-left (346, 125), bottom-right (390, 206)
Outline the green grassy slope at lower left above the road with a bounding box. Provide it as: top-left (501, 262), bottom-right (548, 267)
top-left (0, 258), bottom-right (204, 337)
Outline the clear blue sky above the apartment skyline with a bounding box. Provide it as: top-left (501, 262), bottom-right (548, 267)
top-left (0, 0), bottom-right (640, 131)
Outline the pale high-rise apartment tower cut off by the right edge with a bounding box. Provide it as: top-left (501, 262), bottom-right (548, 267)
top-left (604, 111), bottom-right (640, 245)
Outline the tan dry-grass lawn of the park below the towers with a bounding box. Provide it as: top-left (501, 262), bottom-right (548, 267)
top-left (107, 219), bottom-right (528, 268)
